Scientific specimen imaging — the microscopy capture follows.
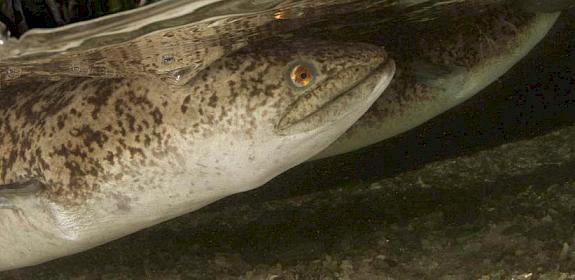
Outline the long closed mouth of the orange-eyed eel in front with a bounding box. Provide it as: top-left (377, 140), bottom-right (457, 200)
top-left (276, 58), bottom-right (395, 135)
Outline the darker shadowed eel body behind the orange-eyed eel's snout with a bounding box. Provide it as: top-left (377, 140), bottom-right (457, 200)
top-left (313, 6), bottom-right (560, 160)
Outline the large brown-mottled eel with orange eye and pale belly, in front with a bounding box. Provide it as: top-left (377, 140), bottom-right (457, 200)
top-left (0, 41), bottom-right (394, 270)
